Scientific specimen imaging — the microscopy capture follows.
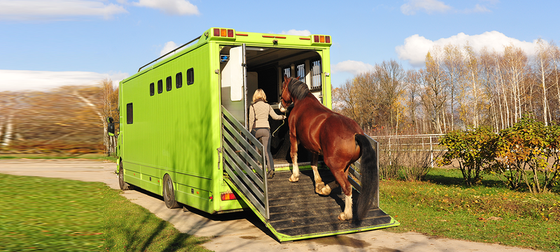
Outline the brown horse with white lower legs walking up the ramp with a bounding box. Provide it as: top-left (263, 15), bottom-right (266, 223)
top-left (280, 76), bottom-right (378, 220)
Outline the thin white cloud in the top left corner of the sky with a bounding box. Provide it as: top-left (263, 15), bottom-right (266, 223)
top-left (0, 0), bottom-right (127, 21)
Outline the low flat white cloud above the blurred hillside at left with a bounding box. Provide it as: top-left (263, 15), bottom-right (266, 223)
top-left (0, 70), bottom-right (129, 92)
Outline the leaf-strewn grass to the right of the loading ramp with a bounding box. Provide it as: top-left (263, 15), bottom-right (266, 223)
top-left (380, 169), bottom-right (560, 251)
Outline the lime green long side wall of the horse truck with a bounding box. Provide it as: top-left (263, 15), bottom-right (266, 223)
top-left (120, 41), bottom-right (221, 211)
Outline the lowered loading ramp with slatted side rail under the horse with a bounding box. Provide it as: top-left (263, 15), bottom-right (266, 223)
top-left (222, 108), bottom-right (399, 242)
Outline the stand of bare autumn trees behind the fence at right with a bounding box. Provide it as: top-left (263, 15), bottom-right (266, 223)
top-left (332, 40), bottom-right (560, 134)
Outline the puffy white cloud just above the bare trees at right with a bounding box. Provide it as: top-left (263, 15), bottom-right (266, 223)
top-left (395, 31), bottom-right (536, 67)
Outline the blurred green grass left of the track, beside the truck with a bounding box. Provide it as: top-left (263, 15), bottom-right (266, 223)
top-left (0, 174), bottom-right (207, 251)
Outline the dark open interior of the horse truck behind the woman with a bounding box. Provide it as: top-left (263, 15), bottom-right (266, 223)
top-left (220, 46), bottom-right (323, 168)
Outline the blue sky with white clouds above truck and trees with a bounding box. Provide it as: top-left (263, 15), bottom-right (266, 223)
top-left (0, 0), bottom-right (560, 92)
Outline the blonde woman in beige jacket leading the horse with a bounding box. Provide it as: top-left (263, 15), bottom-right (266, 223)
top-left (249, 88), bottom-right (286, 178)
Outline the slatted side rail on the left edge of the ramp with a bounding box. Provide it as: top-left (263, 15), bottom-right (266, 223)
top-left (222, 106), bottom-right (270, 220)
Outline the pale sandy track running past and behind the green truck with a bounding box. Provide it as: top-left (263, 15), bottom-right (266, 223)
top-left (0, 159), bottom-right (535, 252)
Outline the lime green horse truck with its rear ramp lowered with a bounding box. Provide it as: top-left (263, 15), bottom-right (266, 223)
top-left (117, 28), bottom-right (398, 241)
